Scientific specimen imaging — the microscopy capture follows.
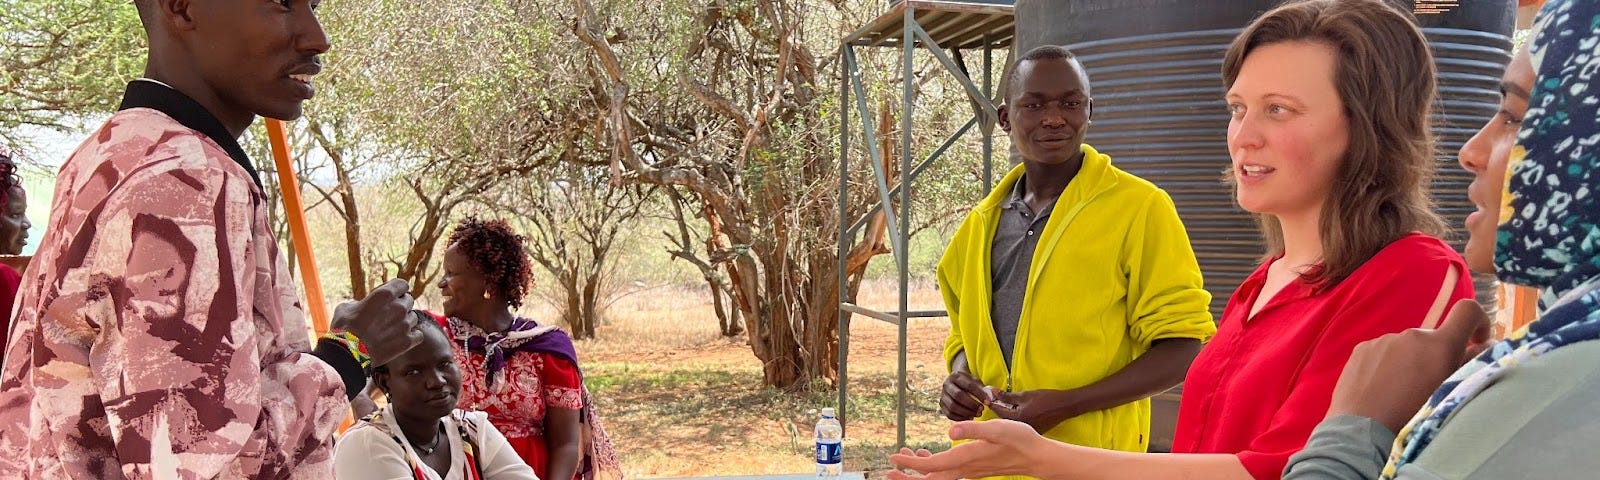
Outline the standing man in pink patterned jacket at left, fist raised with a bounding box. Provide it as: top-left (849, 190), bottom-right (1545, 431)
top-left (0, 0), bottom-right (421, 478)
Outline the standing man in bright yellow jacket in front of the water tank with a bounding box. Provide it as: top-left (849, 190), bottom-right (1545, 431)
top-left (939, 46), bottom-right (1216, 464)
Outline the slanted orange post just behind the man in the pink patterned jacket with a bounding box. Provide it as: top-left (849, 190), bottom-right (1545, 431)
top-left (266, 118), bottom-right (328, 334)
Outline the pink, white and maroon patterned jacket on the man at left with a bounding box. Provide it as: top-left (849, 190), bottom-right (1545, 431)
top-left (0, 109), bottom-right (349, 478)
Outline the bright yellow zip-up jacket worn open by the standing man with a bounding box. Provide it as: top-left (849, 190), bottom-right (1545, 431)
top-left (938, 146), bottom-right (1216, 451)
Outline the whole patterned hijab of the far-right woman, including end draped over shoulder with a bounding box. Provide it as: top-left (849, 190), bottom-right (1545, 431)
top-left (1382, 0), bottom-right (1600, 478)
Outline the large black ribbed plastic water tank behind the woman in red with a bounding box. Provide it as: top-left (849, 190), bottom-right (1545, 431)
top-left (1016, 0), bottom-right (1515, 317)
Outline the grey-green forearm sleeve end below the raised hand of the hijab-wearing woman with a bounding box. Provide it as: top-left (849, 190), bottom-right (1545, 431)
top-left (1283, 414), bottom-right (1395, 480)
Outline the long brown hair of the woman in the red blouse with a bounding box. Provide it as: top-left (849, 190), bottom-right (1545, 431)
top-left (1222, 0), bottom-right (1446, 288)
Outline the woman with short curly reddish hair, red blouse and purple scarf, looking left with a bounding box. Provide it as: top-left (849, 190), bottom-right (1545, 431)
top-left (438, 218), bottom-right (619, 480)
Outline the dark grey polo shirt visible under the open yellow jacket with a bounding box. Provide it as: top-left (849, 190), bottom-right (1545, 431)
top-left (989, 176), bottom-right (1056, 368)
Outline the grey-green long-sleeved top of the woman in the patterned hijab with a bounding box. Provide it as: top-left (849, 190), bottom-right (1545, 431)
top-left (1283, 341), bottom-right (1600, 480)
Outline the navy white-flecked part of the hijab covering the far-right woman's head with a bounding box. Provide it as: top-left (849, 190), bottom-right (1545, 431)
top-left (1494, 0), bottom-right (1600, 309)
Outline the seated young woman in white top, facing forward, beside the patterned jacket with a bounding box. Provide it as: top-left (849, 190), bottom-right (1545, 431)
top-left (334, 312), bottom-right (539, 480)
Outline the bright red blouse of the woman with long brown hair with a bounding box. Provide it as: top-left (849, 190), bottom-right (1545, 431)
top-left (1173, 234), bottom-right (1472, 478)
